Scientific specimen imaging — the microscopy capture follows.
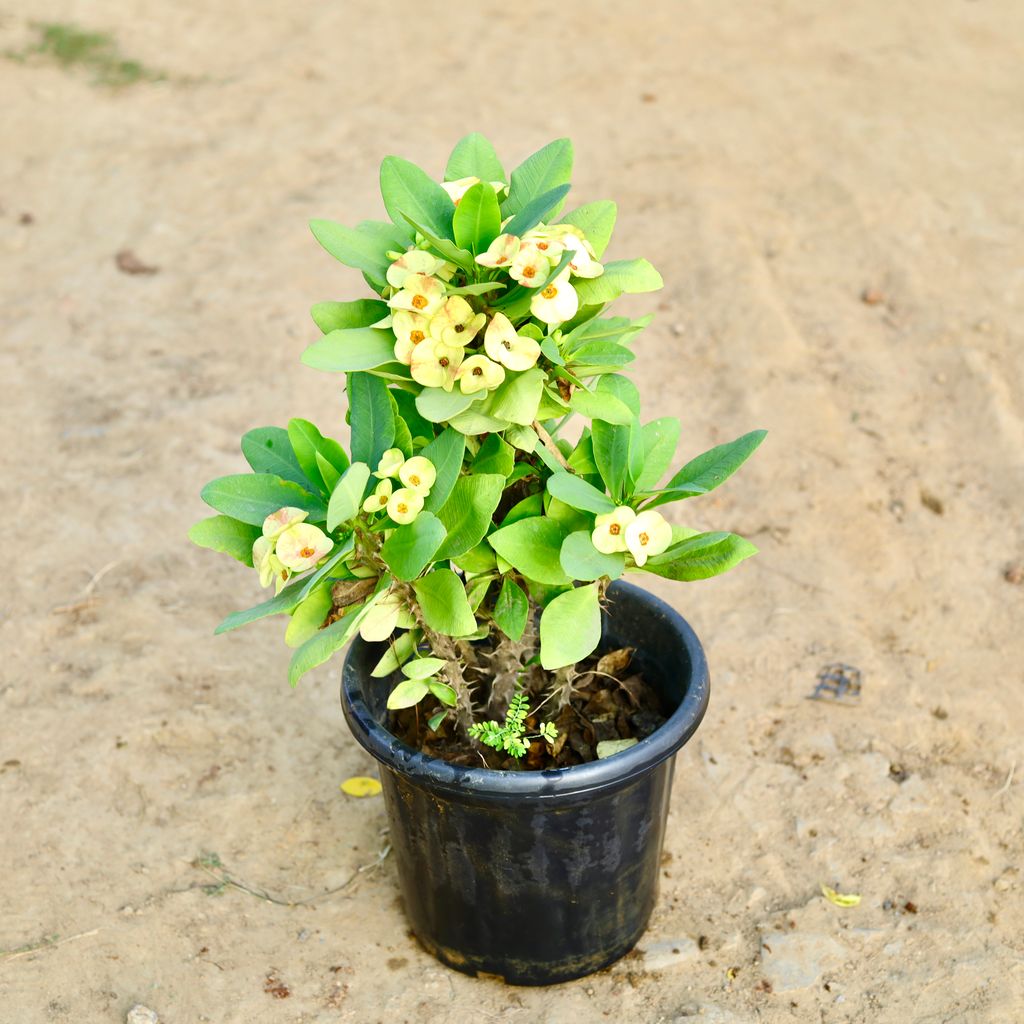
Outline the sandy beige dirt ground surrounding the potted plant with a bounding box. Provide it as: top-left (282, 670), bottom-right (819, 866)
top-left (0, 0), bottom-right (1024, 1024)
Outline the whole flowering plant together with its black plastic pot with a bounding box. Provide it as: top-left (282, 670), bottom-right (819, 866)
top-left (190, 133), bottom-right (764, 984)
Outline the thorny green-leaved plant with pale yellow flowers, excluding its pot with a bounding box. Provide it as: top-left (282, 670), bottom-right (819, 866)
top-left (190, 133), bottom-right (764, 755)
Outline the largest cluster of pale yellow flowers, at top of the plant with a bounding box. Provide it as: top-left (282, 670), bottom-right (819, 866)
top-left (387, 222), bottom-right (604, 394)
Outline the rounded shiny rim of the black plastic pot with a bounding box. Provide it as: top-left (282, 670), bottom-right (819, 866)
top-left (341, 581), bottom-right (710, 801)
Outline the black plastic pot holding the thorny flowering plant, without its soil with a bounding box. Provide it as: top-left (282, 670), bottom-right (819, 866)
top-left (342, 582), bottom-right (709, 985)
